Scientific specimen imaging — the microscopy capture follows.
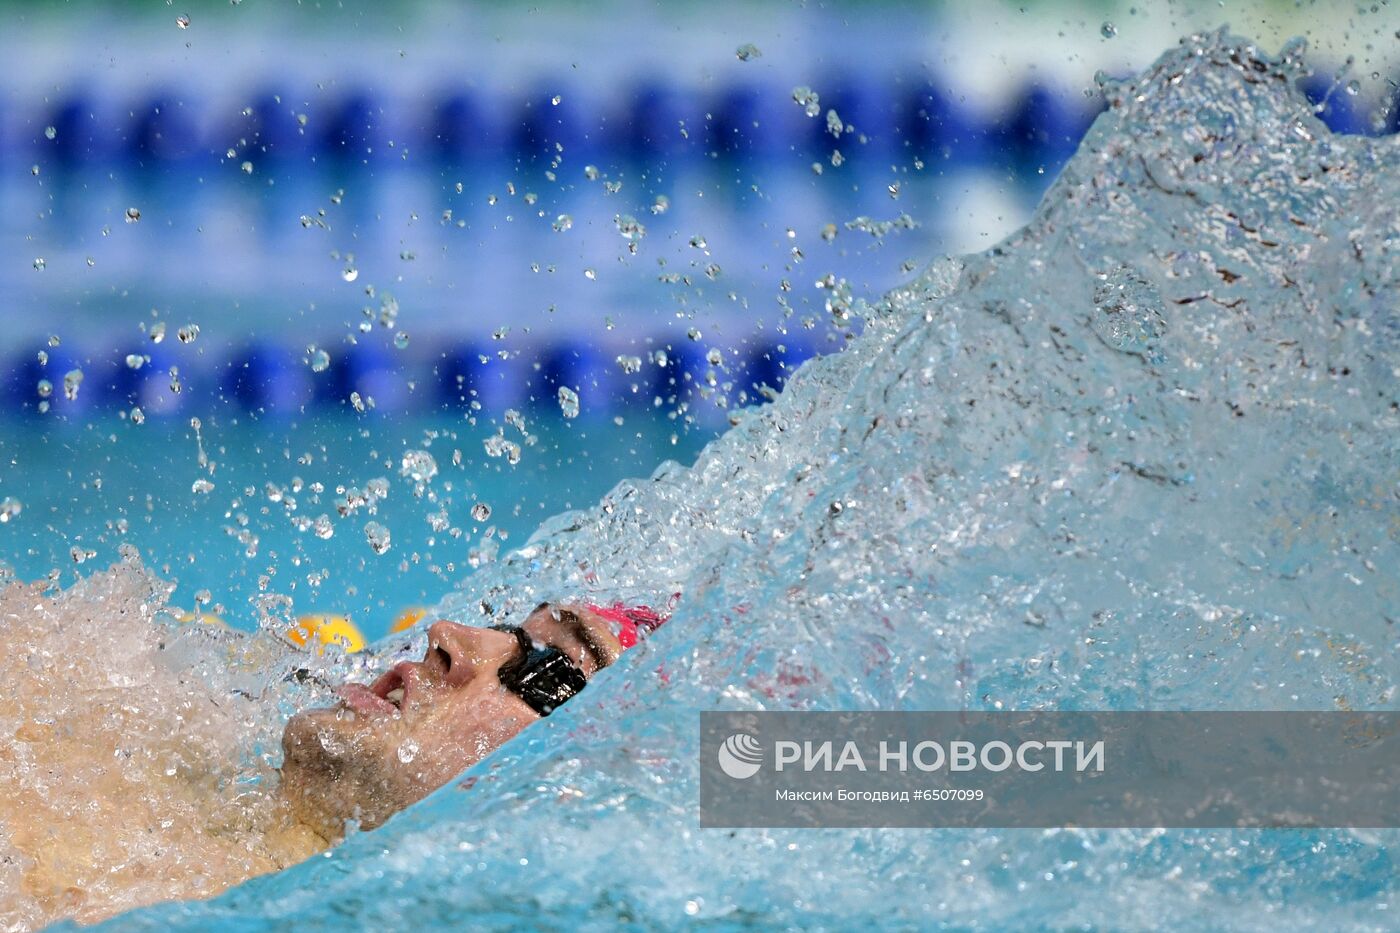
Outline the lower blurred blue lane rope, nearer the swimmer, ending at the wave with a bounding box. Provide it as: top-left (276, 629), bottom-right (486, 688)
top-left (0, 336), bottom-right (819, 417)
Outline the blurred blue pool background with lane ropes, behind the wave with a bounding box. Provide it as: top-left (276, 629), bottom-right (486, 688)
top-left (0, 1), bottom-right (1397, 637)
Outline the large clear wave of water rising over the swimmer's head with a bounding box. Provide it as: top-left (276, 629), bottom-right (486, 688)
top-left (6, 34), bottom-right (1400, 930)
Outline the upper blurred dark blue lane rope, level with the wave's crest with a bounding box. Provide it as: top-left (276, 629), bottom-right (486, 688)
top-left (10, 70), bottom-right (1400, 165)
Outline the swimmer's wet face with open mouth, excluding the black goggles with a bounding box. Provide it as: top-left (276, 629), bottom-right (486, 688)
top-left (281, 604), bottom-right (622, 839)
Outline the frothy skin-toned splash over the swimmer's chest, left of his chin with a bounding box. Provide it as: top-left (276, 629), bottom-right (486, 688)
top-left (0, 559), bottom-right (319, 930)
